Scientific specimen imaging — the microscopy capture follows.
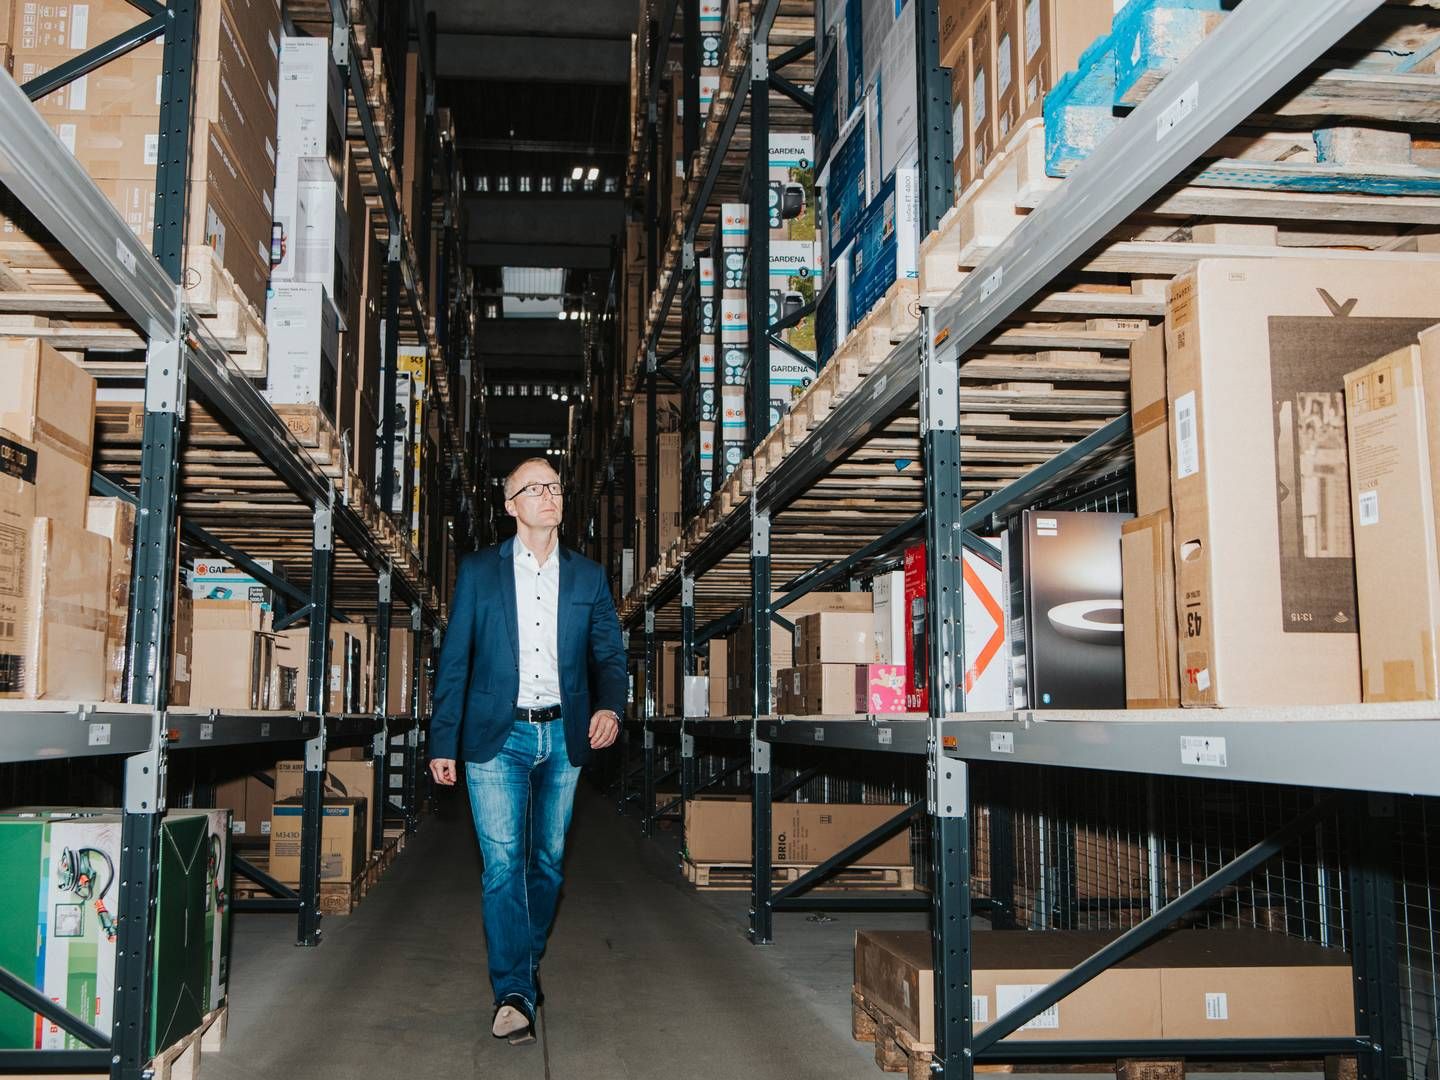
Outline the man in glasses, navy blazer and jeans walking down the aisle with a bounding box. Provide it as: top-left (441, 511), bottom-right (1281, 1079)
top-left (431, 458), bottom-right (628, 1044)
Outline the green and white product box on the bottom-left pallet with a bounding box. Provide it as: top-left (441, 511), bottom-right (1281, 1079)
top-left (0, 808), bottom-right (229, 1054)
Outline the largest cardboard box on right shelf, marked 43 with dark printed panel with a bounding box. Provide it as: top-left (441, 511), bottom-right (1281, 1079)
top-left (1165, 255), bottom-right (1440, 706)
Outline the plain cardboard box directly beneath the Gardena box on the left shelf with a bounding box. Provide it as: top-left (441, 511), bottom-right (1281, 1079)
top-left (190, 600), bottom-right (275, 710)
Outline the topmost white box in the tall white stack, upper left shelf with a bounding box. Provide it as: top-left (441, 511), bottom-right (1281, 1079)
top-left (275, 35), bottom-right (346, 173)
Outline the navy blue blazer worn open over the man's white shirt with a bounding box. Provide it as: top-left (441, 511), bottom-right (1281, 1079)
top-left (431, 537), bottom-right (629, 765)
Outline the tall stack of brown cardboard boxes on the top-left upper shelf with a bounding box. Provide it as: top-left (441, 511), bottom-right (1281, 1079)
top-left (0, 0), bottom-right (281, 312)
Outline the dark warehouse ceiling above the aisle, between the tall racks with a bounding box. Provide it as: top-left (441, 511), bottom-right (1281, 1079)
top-left (428, 0), bottom-right (639, 474)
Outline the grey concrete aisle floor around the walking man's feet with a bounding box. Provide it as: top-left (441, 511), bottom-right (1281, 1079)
top-left (203, 783), bottom-right (923, 1080)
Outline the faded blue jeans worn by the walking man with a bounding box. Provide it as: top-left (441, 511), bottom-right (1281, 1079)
top-left (465, 720), bottom-right (580, 1014)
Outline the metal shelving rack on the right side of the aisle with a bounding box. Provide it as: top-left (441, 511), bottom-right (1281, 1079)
top-left (592, 0), bottom-right (1440, 1079)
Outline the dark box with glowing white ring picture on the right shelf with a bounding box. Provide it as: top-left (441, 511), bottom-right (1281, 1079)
top-left (1009, 510), bottom-right (1132, 708)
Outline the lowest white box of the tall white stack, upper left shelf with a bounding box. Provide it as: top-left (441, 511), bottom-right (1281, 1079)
top-left (265, 281), bottom-right (340, 413)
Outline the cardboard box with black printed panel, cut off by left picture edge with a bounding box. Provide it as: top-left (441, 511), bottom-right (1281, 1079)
top-left (0, 431), bottom-right (36, 698)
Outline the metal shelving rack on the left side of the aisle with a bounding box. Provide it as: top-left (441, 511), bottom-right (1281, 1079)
top-left (0, 0), bottom-right (488, 1080)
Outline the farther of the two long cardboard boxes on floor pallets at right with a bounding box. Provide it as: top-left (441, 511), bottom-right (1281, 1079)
top-left (685, 796), bottom-right (910, 867)
